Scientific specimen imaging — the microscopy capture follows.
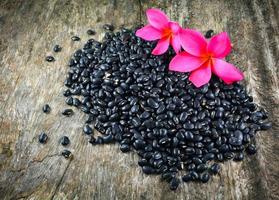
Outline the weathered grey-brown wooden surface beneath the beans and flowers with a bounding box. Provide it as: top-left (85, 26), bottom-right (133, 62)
top-left (0, 0), bottom-right (279, 200)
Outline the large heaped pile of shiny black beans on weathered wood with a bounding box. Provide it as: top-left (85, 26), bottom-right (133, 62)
top-left (64, 29), bottom-right (271, 190)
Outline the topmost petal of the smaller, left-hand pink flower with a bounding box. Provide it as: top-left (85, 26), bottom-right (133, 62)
top-left (146, 8), bottom-right (169, 30)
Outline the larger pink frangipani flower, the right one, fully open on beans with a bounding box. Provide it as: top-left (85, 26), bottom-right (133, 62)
top-left (169, 29), bottom-right (243, 87)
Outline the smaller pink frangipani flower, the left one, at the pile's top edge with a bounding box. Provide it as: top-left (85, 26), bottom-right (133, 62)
top-left (136, 8), bottom-right (184, 55)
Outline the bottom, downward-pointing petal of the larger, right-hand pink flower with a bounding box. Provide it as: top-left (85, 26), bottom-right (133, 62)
top-left (189, 62), bottom-right (211, 87)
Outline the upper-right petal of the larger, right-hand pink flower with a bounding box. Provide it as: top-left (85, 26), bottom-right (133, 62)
top-left (208, 32), bottom-right (231, 58)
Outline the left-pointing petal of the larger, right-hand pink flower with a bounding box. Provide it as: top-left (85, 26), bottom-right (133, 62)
top-left (169, 52), bottom-right (207, 72)
